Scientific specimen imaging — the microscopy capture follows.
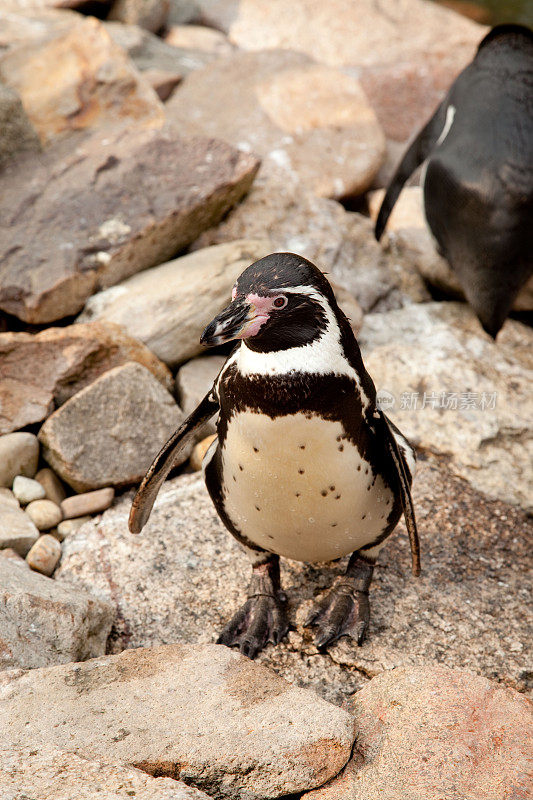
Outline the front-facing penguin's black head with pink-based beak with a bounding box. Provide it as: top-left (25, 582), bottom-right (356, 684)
top-left (200, 253), bottom-right (339, 352)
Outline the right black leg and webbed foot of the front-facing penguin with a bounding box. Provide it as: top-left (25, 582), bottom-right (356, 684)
top-left (304, 556), bottom-right (374, 648)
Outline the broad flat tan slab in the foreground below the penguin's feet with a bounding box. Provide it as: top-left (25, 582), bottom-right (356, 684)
top-left (0, 645), bottom-right (354, 800)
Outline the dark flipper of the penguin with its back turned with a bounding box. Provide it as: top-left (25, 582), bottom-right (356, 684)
top-left (374, 98), bottom-right (448, 242)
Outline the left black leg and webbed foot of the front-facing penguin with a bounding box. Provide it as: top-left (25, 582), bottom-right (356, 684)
top-left (217, 557), bottom-right (289, 658)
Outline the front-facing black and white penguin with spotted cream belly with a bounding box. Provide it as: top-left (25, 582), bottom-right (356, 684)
top-left (130, 253), bottom-right (419, 658)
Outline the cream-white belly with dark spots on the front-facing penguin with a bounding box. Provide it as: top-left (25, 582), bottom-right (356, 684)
top-left (217, 411), bottom-right (393, 561)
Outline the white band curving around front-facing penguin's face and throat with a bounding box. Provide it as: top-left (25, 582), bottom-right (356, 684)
top-left (236, 286), bottom-right (369, 408)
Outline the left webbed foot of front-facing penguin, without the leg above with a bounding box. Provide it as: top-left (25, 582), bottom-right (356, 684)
top-left (217, 592), bottom-right (289, 658)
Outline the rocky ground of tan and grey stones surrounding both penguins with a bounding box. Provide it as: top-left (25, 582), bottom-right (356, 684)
top-left (0, 0), bottom-right (533, 800)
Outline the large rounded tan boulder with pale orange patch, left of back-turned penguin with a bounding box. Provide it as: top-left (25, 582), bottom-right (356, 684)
top-left (165, 50), bottom-right (385, 197)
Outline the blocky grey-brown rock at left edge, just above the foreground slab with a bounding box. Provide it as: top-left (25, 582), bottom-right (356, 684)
top-left (0, 556), bottom-right (113, 668)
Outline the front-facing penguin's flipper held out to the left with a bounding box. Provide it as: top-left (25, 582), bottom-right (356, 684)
top-left (128, 390), bottom-right (219, 533)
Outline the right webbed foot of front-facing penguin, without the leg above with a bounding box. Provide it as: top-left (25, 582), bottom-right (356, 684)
top-left (304, 586), bottom-right (370, 649)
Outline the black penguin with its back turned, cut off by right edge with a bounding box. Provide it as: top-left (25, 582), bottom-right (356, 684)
top-left (375, 25), bottom-right (533, 338)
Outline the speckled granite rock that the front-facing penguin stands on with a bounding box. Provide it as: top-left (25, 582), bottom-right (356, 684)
top-left (55, 458), bottom-right (533, 702)
